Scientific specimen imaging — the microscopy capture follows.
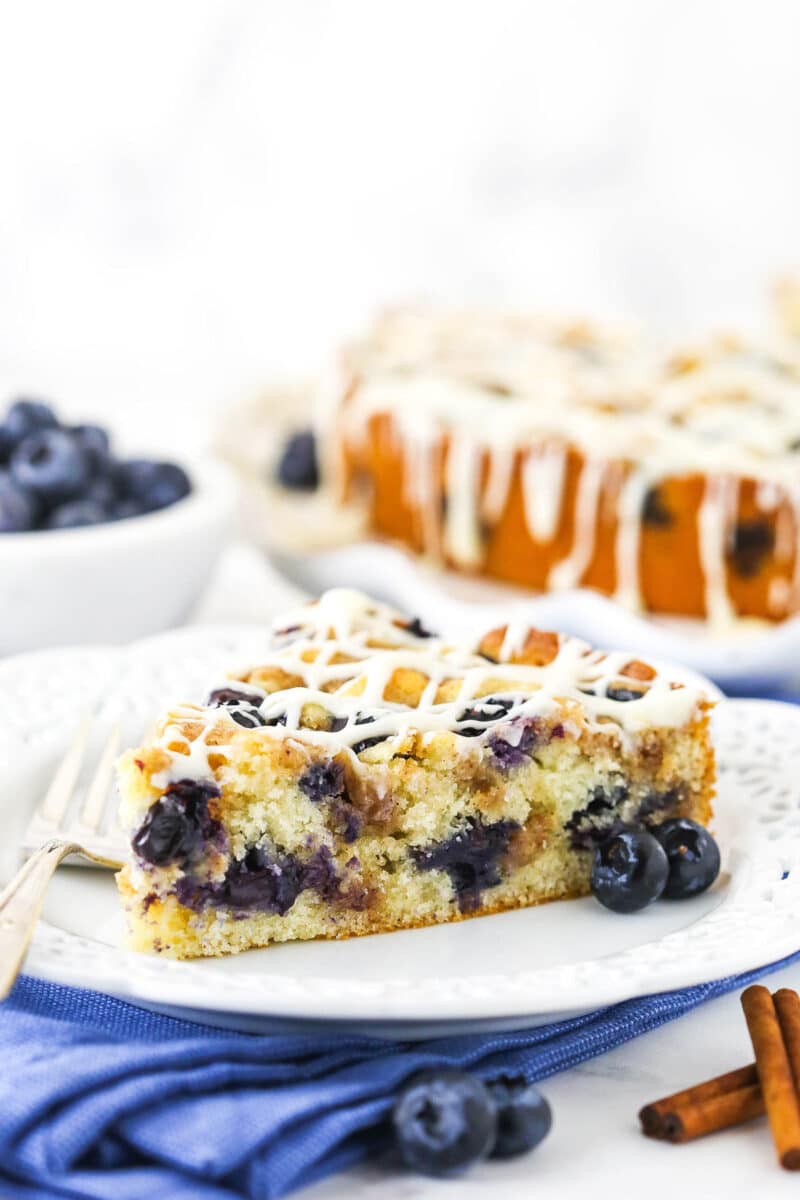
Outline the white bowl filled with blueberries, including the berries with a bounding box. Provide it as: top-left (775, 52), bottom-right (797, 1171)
top-left (0, 398), bottom-right (236, 654)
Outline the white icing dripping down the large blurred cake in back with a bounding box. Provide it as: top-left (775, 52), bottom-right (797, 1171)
top-left (327, 308), bottom-right (800, 622)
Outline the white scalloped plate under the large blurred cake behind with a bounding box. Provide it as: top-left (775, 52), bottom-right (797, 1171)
top-left (267, 541), bottom-right (800, 691)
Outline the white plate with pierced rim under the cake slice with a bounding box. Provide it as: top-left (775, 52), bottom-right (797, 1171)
top-left (0, 628), bottom-right (800, 1038)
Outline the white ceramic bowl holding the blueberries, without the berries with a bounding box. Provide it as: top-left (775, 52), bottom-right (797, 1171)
top-left (0, 462), bottom-right (236, 654)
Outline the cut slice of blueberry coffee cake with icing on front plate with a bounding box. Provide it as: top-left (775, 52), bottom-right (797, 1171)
top-left (119, 589), bottom-right (714, 958)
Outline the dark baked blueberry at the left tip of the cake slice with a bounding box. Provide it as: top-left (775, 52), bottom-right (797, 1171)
top-left (132, 779), bottom-right (219, 866)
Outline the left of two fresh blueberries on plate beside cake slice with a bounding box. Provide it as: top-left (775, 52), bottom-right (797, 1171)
top-left (591, 829), bottom-right (669, 912)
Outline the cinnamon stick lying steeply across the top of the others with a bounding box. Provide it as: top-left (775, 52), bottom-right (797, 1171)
top-left (741, 984), bottom-right (800, 1171)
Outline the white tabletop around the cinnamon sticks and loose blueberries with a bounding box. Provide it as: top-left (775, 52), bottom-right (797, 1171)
top-left (300, 966), bottom-right (800, 1200)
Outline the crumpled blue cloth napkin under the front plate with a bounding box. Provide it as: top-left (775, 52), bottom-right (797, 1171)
top-left (0, 953), bottom-right (800, 1200)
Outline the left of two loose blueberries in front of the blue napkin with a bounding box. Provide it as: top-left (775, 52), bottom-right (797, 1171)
top-left (392, 1069), bottom-right (498, 1176)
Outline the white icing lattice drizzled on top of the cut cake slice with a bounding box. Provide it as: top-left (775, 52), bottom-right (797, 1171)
top-left (148, 588), bottom-right (705, 787)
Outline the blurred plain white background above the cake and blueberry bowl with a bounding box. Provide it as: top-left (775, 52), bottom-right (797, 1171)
top-left (0, 0), bottom-right (800, 448)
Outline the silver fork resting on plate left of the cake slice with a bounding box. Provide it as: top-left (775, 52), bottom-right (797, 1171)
top-left (0, 719), bottom-right (125, 1000)
